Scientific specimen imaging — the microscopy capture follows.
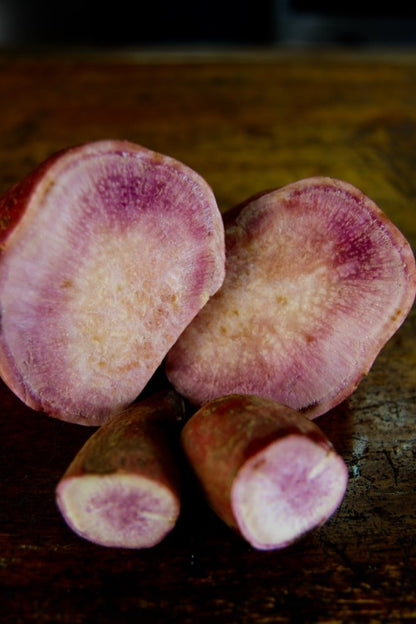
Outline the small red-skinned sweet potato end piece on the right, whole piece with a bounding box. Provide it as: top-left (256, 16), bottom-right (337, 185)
top-left (181, 395), bottom-right (348, 550)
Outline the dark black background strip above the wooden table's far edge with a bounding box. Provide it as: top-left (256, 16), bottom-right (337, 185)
top-left (0, 0), bottom-right (416, 48)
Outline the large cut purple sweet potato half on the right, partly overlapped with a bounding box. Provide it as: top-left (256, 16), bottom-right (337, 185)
top-left (166, 178), bottom-right (416, 418)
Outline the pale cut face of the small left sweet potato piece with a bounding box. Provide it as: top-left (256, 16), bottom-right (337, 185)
top-left (56, 473), bottom-right (180, 549)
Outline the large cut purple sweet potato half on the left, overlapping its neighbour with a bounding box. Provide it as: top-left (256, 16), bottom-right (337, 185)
top-left (0, 140), bottom-right (225, 426)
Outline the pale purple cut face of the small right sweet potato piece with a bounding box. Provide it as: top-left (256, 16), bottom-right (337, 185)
top-left (231, 435), bottom-right (348, 550)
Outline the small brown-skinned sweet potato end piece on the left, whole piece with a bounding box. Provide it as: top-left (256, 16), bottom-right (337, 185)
top-left (56, 392), bottom-right (183, 548)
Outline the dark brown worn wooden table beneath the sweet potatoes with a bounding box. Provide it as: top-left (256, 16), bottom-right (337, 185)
top-left (0, 50), bottom-right (416, 624)
